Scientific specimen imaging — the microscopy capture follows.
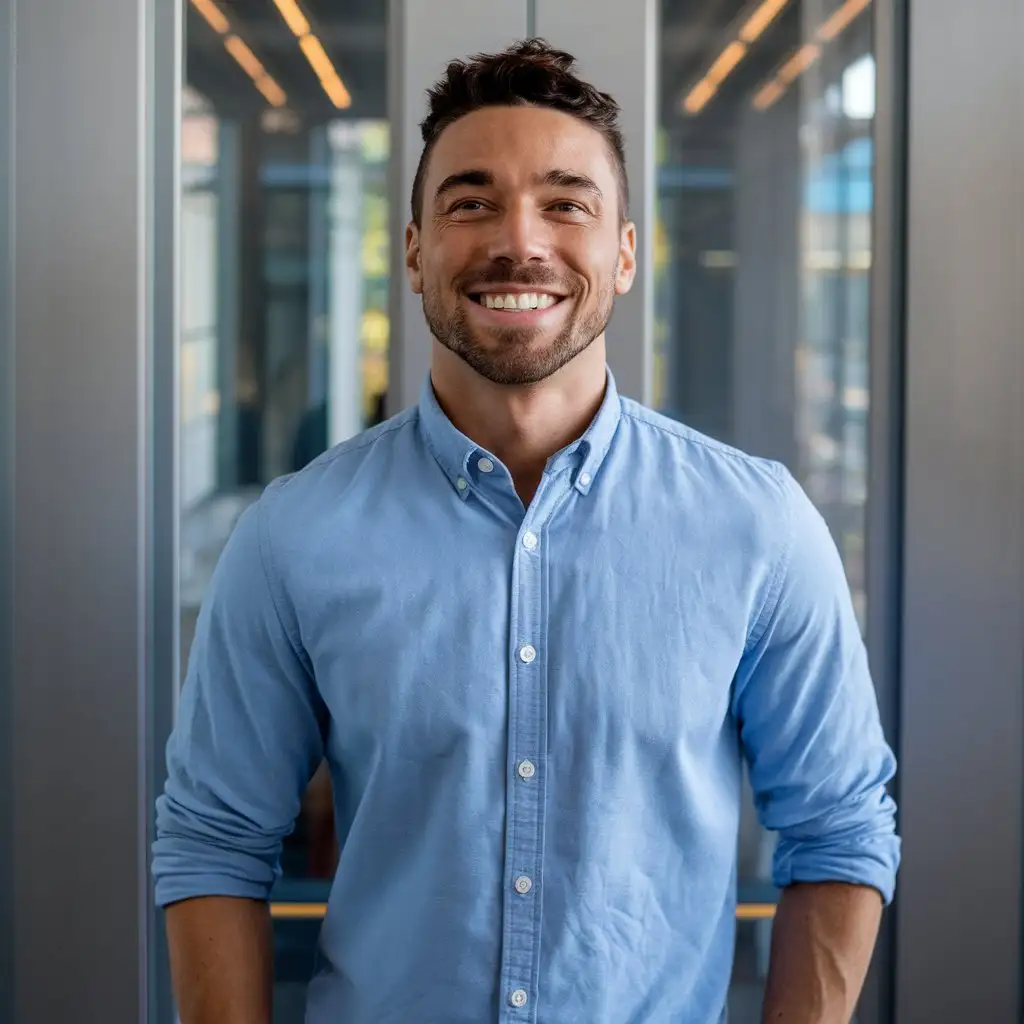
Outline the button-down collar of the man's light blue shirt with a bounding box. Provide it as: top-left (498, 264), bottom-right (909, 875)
top-left (419, 368), bottom-right (622, 498)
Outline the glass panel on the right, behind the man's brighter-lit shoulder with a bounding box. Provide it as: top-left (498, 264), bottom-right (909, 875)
top-left (654, 0), bottom-right (874, 1022)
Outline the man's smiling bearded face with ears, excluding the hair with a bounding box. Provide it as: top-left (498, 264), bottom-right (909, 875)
top-left (406, 106), bottom-right (636, 385)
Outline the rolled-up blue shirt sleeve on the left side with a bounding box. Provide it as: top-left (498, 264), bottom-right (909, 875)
top-left (153, 496), bottom-right (326, 906)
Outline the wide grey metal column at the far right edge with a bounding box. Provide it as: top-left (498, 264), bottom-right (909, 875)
top-left (895, 0), bottom-right (1024, 1024)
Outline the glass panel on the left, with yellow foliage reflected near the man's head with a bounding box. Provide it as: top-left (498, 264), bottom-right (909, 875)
top-left (180, 0), bottom-right (389, 1024)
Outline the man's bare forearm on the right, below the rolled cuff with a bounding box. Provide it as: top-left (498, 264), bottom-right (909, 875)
top-left (763, 882), bottom-right (882, 1024)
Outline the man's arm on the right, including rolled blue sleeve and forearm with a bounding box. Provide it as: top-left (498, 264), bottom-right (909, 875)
top-left (733, 473), bottom-right (900, 1024)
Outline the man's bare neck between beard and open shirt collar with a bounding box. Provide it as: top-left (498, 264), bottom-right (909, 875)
top-left (430, 337), bottom-right (606, 505)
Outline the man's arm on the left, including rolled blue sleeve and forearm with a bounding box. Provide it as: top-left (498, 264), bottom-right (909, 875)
top-left (153, 496), bottom-right (327, 1024)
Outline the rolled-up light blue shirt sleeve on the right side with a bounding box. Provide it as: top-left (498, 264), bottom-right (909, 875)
top-left (733, 467), bottom-right (900, 903)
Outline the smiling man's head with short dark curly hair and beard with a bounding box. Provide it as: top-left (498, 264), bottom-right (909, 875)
top-left (406, 40), bottom-right (636, 385)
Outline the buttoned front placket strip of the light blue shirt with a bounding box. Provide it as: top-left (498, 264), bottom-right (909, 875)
top-left (499, 476), bottom-right (567, 1024)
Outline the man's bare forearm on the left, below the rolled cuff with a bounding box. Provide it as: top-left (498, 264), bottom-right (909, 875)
top-left (167, 896), bottom-right (273, 1024)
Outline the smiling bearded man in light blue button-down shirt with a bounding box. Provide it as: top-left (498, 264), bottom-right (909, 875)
top-left (155, 41), bottom-right (899, 1024)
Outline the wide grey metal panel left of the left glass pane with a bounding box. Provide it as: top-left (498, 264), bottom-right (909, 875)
top-left (11, 0), bottom-right (149, 1022)
